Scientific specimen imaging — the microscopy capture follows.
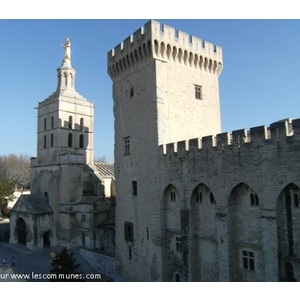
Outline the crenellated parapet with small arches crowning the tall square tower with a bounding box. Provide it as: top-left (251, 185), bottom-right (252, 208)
top-left (107, 20), bottom-right (223, 79)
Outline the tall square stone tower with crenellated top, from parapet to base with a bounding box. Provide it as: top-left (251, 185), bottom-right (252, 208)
top-left (108, 21), bottom-right (223, 281)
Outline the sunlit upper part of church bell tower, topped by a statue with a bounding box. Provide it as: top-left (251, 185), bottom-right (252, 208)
top-left (37, 38), bottom-right (94, 165)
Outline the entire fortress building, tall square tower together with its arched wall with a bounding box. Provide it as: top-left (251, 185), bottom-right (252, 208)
top-left (108, 21), bottom-right (300, 281)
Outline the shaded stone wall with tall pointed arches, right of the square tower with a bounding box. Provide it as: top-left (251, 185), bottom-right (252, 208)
top-left (161, 119), bottom-right (300, 281)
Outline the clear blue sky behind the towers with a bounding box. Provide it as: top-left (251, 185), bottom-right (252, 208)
top-left (0, 18), bottom-right (300, 162)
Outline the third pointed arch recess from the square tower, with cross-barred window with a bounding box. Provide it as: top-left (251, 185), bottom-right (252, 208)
top-left (228, 182), bottom-right (264, 281)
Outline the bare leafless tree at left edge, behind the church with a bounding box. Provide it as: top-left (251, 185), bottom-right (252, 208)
top-left (0, 154), bottom-right (30, 189)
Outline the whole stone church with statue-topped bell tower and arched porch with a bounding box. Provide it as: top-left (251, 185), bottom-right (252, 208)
top-left (10, 39), bottom-right (115, 255)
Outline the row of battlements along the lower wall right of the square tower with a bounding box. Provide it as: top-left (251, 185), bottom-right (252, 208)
top-left (160, 119), bottom-right (300, 155)
